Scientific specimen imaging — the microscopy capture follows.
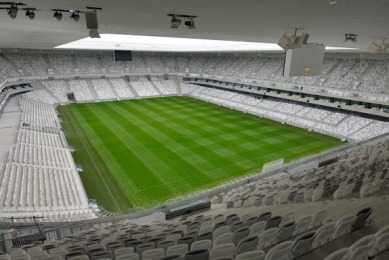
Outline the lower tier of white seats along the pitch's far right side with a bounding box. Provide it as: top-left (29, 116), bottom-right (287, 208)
top-left (183, 84), bottom-right (388, 141)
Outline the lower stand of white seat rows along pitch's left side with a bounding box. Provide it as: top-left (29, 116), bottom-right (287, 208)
top-left (0, 98), bottom-right (96, 222)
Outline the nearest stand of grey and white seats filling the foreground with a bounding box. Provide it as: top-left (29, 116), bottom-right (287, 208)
top-left (1, 138), bottom-right (389, 259)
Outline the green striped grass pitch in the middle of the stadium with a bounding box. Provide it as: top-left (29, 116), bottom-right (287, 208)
top-left (58, 97), bottom-right (341, 213)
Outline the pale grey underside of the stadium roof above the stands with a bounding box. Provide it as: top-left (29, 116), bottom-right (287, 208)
top-left (0, 0), bottom-right (389, 51)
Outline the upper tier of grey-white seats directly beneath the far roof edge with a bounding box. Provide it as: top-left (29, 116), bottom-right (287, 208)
top-left (0, 53), bottom-right (389, 94)
